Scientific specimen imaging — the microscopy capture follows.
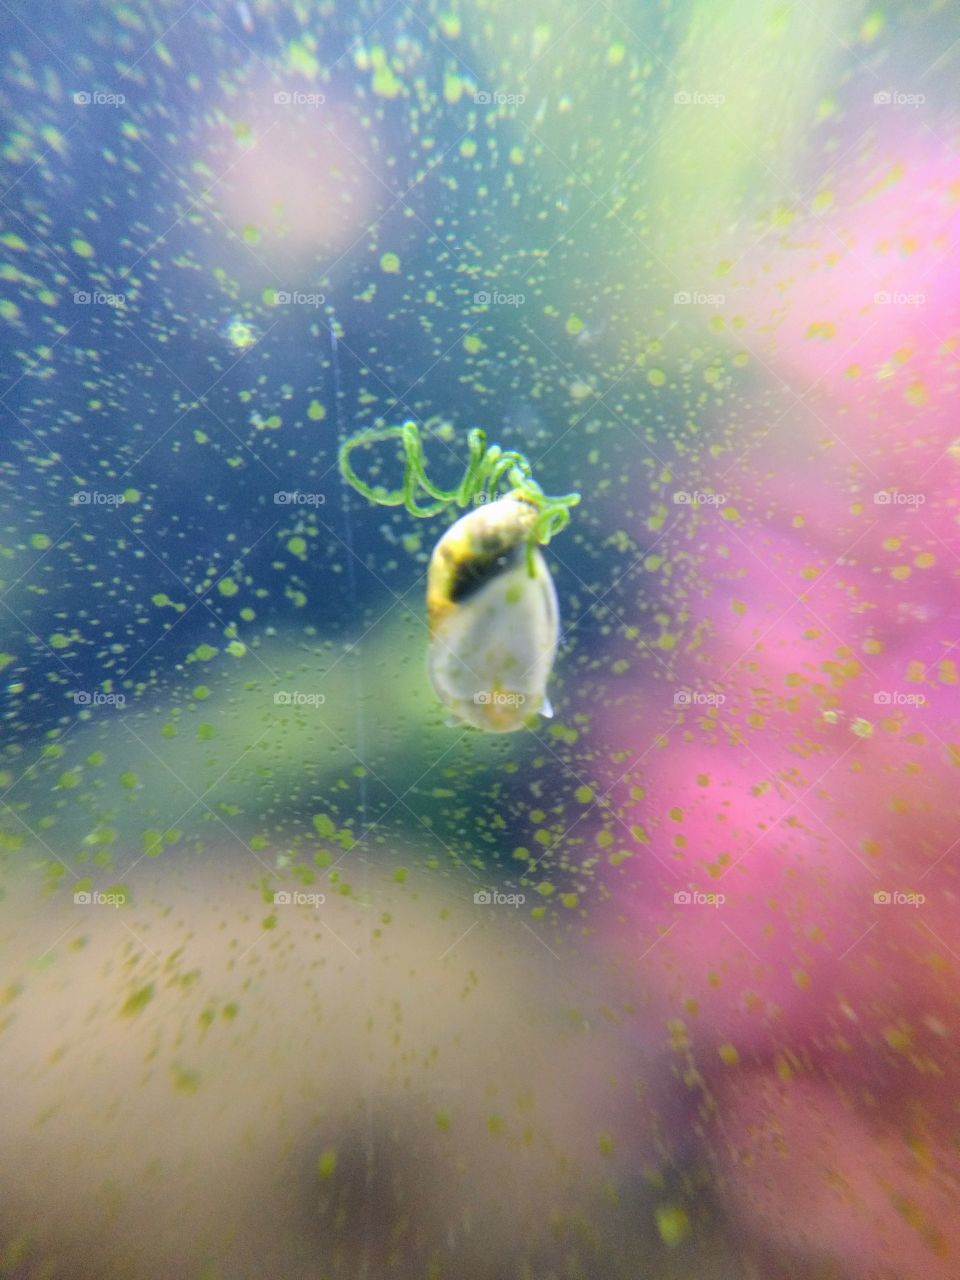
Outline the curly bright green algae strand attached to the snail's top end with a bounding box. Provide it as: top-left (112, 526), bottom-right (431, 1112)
top-left (339, 421), bottom-right (580, 545)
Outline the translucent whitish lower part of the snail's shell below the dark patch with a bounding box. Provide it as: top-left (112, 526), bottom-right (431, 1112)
top-left (428, 508), bottom-right (559, 733)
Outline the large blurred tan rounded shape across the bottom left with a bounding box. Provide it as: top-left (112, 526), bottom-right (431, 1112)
top-left (0, 861), bottom-right (675, 1280)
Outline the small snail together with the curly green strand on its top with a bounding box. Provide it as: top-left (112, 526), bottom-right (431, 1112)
top-left (339, 422), bottom-right (580, 733)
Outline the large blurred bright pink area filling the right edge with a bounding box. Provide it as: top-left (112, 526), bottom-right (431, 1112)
top-left (604, 138), bottom-right (960, 1280)
